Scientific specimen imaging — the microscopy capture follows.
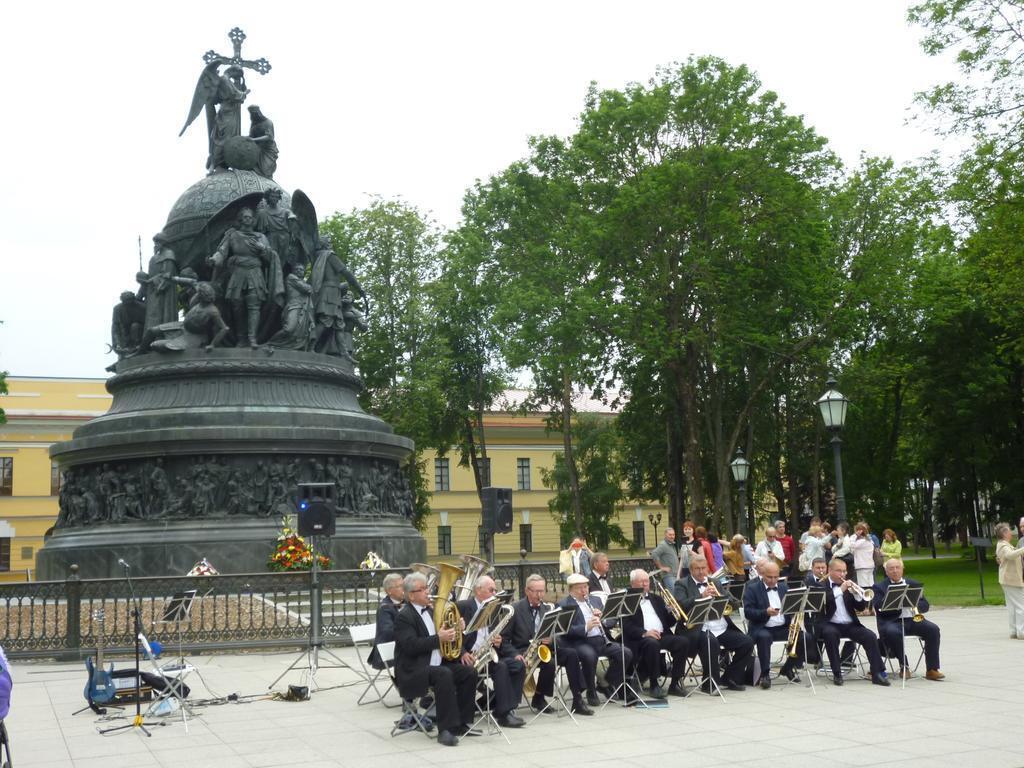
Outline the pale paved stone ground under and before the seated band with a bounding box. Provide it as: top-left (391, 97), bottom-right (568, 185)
top-left (7, 606), bottom-right (1024, 768)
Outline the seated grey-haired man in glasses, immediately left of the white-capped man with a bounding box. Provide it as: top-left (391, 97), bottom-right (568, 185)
top-left (503, 573), bottom-right (594, 716)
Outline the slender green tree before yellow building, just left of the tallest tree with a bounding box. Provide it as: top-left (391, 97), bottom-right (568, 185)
top-left (463, 138), bottom-right (610, 530)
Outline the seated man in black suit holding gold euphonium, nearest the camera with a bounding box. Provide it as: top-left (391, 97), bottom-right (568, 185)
top-left (394, 573), bottom-right (476, 746)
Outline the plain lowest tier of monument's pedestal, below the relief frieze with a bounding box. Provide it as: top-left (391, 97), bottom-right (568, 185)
top-left (37, 519), bottom-right (426, 581)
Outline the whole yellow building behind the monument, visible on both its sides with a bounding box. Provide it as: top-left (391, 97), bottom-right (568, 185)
top-left (0, 377), bottom-right (665, 580)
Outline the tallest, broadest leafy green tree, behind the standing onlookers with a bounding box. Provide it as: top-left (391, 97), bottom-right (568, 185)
top-left (571, 57), bottom-right (838, 527)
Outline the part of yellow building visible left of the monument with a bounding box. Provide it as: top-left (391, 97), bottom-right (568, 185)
top-left (0, 377), bottom-right (111, 580)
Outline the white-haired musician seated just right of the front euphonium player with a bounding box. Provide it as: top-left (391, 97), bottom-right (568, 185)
top-left (458, 575), bottom-right (526, 728)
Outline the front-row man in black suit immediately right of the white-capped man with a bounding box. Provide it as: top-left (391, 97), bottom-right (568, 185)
top-left (623, 568), bottom-right (696, 698)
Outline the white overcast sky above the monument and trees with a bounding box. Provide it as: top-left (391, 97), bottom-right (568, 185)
top-left (0, 0), bottom-right (954, 377)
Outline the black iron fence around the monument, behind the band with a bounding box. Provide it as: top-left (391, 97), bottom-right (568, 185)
top-left (0, 557), bottom-right (652, 658)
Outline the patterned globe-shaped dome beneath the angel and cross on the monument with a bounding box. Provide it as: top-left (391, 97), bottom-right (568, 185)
top-left (164, 169), bottom-right (291, 262)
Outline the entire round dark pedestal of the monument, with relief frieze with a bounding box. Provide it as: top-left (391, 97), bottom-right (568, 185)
top-left (37, 349), bottom-right (426, 580)
